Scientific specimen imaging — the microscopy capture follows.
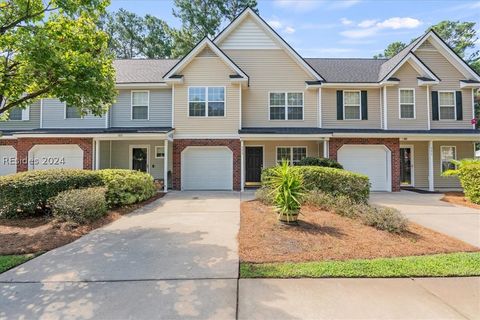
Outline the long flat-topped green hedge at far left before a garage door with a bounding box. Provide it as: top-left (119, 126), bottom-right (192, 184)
top-left (0, 169), bottom-right (103, 219)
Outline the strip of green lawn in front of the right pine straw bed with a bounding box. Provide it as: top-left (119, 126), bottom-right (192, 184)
top-left (240, 252), bottom-right (480, 278)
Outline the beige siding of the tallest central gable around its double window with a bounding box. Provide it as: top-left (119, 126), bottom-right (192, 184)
top-left (225, 50), bottom-right (318, 127)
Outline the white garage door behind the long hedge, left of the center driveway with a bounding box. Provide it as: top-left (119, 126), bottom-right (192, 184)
top-left (28, 144), bottom-right (83, 170)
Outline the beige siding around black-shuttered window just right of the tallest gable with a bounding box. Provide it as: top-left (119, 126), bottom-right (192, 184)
top-left (322, 88), bottom-right (382, 129)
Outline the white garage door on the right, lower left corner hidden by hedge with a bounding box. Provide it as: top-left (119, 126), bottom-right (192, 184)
top-left (337, 146), bottom-right (391, 191)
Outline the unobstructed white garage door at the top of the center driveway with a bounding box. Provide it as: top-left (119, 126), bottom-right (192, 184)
top-left (182, 147), bottom-right (233, 190)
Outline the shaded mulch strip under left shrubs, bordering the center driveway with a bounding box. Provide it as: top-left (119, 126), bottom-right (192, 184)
top-left (0, 193), bottom-right (165, 255)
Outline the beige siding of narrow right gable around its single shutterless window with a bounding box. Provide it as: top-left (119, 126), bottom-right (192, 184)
top-left (387, 63), bottom-right (429, 130)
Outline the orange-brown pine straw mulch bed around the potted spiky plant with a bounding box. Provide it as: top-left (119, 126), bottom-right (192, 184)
top-left (239, 201), bottom-right (480, 263)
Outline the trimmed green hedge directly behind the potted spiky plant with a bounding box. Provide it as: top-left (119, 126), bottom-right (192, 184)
top-left (262, 166), bottom-right (370, 202)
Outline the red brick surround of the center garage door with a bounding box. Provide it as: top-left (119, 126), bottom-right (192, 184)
top-left (173, 139), bottom-right (242, 191)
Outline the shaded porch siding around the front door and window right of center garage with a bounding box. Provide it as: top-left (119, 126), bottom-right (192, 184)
top-left (245, 141), bottom-right (323, 168)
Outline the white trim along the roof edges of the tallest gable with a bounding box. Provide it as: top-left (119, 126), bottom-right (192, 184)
top-left (213, 8), bottom-right (324, 81)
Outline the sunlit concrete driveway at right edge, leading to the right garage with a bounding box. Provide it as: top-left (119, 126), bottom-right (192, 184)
top-left (370, 191), bottom-right (480, 247)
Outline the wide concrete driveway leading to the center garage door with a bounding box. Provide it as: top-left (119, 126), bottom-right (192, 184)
top-left (0, 192), bottom-right (240, 319)
